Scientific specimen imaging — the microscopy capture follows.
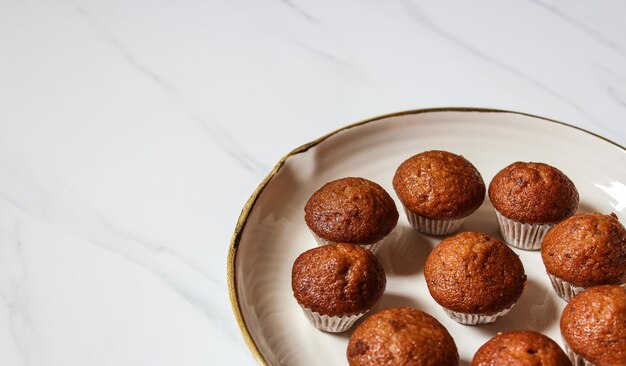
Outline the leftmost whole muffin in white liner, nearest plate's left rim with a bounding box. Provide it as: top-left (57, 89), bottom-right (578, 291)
top-left (291, 243), bottom-right (387, 333)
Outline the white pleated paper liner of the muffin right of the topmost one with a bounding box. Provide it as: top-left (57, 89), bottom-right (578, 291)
top-left (494, 210), bottom-right (554, 250)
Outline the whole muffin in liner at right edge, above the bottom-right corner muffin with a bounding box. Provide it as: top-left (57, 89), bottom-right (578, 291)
top-left (541, 213), bottom-right (626, 301)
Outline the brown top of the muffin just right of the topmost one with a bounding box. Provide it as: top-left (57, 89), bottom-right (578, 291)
top-left (489, 161), bottom-right (578, 224)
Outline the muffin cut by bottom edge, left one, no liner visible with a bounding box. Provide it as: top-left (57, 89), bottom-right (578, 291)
top-left (347, 307), bottom-right (459, 366)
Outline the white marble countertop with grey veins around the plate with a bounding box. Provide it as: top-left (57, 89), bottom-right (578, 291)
top-left (0, 0), bottom-right (626, 366)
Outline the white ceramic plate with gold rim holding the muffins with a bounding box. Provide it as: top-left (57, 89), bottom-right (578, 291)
top-left (228, 108), bottom-right (626, 366)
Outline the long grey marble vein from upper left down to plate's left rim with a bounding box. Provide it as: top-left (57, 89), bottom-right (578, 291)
top-left (68, 0), bottom-right (268, 175)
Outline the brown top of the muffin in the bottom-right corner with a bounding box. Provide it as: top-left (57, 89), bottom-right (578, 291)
top-left (561, 285), bottom-right (626, 366)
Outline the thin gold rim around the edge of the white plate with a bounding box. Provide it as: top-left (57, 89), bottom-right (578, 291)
top-left (226, 107), bottom-right (626, 366)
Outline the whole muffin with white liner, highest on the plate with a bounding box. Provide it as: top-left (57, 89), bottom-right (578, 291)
top-left (393, 150), bottom-right (485, 235)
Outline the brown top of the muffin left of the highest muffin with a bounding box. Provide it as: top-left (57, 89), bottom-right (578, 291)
top-left (304, 178), bottom-right (398, 244)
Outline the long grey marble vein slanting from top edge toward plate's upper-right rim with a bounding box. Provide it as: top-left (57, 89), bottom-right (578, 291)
top-left (402, 0), bottom-right (603, 126)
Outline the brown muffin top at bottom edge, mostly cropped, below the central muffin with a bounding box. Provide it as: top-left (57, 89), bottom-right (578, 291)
top-left (472, 330), bottom-right (572, 366)
